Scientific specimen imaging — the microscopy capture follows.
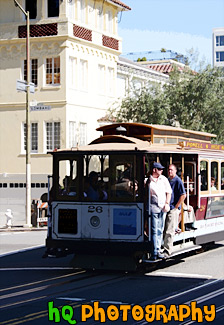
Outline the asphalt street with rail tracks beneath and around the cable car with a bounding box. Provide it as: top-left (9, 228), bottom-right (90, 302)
top-left (0, 231), bottom-right (224, 325)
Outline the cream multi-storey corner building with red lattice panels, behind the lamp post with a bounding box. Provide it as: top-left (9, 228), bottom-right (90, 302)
top-left (0, 0), bottom-right (130, 223)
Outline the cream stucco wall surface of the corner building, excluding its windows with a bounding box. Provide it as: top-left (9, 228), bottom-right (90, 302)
top-left (0, 0), bottom-right (121, 174)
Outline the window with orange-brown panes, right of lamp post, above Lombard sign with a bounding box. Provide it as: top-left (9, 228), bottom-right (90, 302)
top-left (46, 57), bottom-right (60, 85)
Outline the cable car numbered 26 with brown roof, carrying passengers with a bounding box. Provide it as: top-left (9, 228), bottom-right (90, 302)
top-left (46, 123), bottom-right (224, 270)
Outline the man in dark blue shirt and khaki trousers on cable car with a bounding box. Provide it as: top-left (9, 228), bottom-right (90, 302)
top-left (163, 164), bottom-right (186, 257)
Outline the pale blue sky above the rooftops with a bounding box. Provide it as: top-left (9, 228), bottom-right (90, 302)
top-left (118, 0), bottom-right (224, 64)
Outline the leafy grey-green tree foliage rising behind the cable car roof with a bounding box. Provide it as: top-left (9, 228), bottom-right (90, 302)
top-left (112, 66), bottom-right (224, 143)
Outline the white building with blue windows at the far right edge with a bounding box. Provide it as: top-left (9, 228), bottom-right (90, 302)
top-left (212, 27), bottom-right (224, 68)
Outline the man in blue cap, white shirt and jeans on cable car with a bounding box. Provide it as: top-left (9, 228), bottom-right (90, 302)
top-left (148, 162), bottom-right (172, 261)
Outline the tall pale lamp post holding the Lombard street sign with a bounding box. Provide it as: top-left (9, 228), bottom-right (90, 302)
top-left (14, 0), bottom-right (32, 227)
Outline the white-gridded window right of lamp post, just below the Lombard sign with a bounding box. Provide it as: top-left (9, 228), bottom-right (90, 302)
top-left (46, 122), bottom-right (61, 150)
